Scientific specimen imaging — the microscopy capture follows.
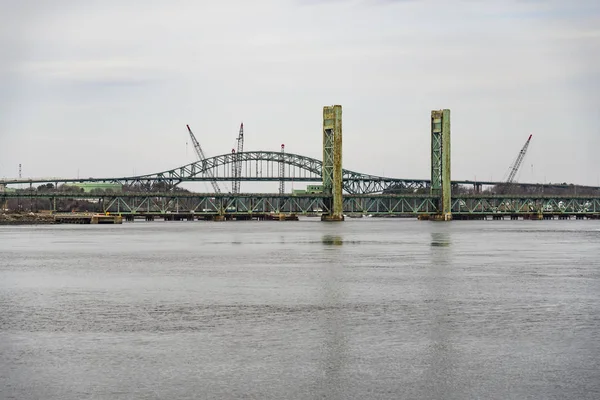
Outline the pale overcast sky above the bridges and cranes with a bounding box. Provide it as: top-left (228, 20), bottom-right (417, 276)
top-left (0, 0), bottom-right (600, 191)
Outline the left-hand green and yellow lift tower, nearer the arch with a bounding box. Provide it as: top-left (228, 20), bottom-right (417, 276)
top-left (321, 105), bottom-right (344, 221)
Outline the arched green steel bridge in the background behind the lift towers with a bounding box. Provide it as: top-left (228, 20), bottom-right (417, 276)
top-left (0, 151), bottom-right (600, 195)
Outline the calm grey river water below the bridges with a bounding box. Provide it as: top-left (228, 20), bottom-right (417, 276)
top-left (0, 218), bottom-right (600, 399)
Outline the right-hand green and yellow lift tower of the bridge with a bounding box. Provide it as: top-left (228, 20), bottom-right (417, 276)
top-left (431, 109), bottom-right (452, 221)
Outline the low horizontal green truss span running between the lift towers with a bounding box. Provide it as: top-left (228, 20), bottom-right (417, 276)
top-left (0, 191), bottom-right (600, 219)
